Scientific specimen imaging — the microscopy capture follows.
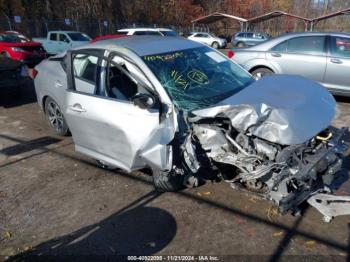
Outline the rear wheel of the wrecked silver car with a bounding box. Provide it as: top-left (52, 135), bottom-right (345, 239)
top-left (45, 97), bottom-right (69, 136)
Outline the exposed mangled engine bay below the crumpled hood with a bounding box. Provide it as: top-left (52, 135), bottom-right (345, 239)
top-left (179, 115), bottom-right (348, 221)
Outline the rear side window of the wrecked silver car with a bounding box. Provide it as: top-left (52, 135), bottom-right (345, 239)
top-left (73, 54), bottom-right (98, 94)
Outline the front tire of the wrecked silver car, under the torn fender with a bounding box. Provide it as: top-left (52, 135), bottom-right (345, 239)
top-left (152, 170), bottom-right (184, 192)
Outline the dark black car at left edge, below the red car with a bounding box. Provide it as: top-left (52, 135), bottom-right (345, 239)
top-left (0, 57), bottom-right (28, 97)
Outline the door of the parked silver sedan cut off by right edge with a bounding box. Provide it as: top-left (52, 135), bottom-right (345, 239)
top-left (324, 36), bottom-right (350, 94)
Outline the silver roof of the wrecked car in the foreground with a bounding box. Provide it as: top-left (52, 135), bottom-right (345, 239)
top-left (81, 36), bottom-right (203, 56)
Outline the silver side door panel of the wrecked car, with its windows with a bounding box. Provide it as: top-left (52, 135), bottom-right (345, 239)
top-left (65, 50), bottom-right (163, 172)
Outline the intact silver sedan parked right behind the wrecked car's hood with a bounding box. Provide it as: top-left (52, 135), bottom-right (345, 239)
top-left (232, 33), bottom-right (350, 96)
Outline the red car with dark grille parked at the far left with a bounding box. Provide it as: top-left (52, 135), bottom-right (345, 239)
top-left (0, 31), bottom-right (46, 66)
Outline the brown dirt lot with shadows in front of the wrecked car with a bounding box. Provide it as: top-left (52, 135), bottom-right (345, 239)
top-left (0, 81), bottom-right (350, 261)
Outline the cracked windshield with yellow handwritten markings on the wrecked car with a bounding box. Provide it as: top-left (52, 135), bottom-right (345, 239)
top-left (142, 46), bottom-right (254, 111)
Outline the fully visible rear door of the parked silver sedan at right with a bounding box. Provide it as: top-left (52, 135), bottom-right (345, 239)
top-left (266, 36), bottom-right (327, 83)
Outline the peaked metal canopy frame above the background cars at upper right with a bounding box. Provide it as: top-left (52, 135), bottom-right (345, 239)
top-left (191, 8), bottom-right (350, 31)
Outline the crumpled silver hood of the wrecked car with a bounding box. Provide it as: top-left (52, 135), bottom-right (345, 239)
top-left (192, 75), bottom-right (336, 145)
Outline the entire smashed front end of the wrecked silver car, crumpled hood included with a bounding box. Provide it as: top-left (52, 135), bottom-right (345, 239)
top-left (179, 76), bottom-right (350, 221)
